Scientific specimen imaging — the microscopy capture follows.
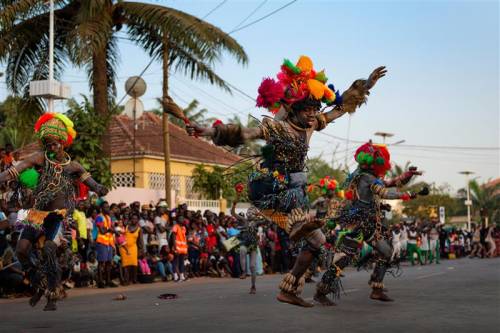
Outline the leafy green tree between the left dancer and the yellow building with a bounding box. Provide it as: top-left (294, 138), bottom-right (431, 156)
top-left (67, 96), bottom-right (116, 188)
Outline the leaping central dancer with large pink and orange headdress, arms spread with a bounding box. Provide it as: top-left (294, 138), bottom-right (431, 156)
top-left (182, 56), bottom-right (386, 306)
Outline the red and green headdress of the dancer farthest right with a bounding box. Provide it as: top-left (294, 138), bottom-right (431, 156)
top-left (354, 141), bottom-right (391, 177)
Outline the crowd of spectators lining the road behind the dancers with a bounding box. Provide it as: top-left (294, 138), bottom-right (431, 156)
top-left (0, 184), bottom-right (500, 294)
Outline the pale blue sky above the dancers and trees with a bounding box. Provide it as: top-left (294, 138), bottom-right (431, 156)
top-left (0, 0), bottom-right (500, 189)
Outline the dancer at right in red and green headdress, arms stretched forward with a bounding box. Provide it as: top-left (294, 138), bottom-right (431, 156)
top-left (314, 142), bottom-right (429, 305)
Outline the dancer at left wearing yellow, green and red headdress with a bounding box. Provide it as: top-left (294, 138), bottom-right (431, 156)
top-left (0, 113), bottom-right (107, 311)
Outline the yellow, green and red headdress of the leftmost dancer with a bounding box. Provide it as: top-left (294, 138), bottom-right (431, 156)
top-left (35, 113), bottom-right (76, 147)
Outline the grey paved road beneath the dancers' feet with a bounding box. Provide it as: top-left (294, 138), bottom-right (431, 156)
top-left (0, 259), bottom-right (500, 333)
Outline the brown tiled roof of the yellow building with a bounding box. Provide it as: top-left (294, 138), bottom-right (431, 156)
top-left (107, 112), bottom-right (240, 165)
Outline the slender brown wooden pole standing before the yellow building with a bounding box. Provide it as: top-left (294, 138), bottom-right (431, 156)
top-left (162, 35), bottom-right (173, 208)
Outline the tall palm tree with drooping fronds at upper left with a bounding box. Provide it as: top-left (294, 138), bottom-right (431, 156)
top-left (0, 0), bottom-right (247, 115)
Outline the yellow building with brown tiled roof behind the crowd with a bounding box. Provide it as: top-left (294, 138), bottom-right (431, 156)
top-left (107, 112), bottom-right (240, 204)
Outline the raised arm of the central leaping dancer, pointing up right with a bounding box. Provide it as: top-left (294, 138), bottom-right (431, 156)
top-left (324, 66), bottom-right (387, 124)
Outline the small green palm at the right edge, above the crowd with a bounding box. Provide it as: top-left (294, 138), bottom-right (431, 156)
top-left (469, 180), bottom-right (500, 223)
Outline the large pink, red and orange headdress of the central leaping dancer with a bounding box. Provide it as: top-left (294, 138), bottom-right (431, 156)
top-left (257, 56), bottom-right (341, 114)
